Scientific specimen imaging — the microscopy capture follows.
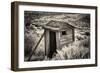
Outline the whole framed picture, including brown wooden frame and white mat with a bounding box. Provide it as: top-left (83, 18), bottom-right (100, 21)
top-left (11, 2), bottom-right (97, 71)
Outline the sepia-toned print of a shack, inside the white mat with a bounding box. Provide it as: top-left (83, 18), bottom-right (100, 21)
top-left (24, 11), bottom-right (91, 61)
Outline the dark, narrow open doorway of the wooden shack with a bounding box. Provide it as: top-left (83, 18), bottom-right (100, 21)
top-left (48, 31), bottom-right (57, 58)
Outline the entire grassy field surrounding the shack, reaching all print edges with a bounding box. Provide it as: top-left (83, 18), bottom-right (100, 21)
top-left (24, 11), bottom-right (90, 61)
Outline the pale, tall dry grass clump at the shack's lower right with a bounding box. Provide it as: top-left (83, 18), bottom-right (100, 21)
top-left (53, 41), bottom-right (90, 60)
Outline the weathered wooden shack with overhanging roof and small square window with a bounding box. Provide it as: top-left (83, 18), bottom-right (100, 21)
top-left (43, 20), bottom-right (75, 58)
